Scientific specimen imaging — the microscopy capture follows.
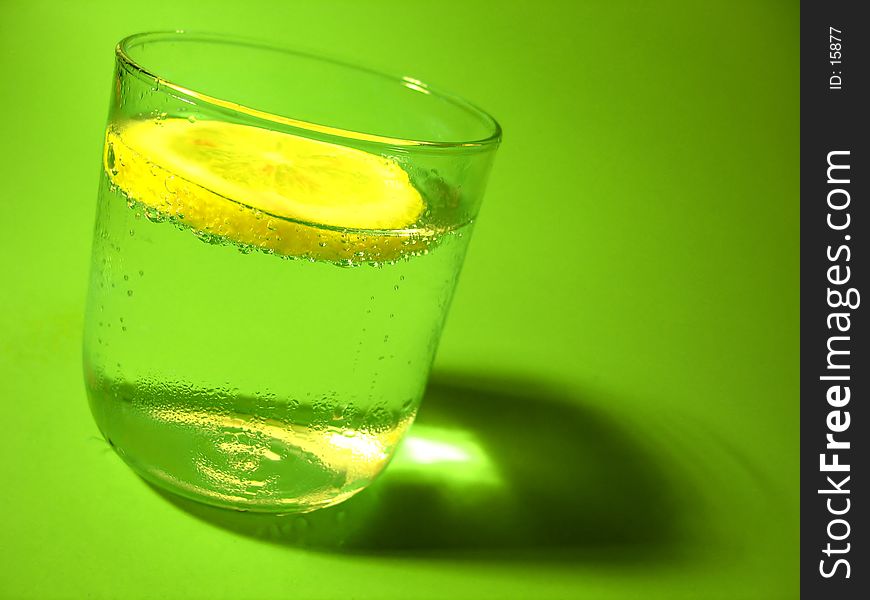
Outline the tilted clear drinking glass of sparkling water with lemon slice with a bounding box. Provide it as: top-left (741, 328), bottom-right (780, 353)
top-left (83, 32), bottom-right (501, 512)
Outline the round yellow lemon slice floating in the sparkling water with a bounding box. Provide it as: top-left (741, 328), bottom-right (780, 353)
top-left (104, 118), bottom-right (433, 262)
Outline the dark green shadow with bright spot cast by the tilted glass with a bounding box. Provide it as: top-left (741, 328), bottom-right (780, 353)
top-left (153, 373), bottom-right (688, 562)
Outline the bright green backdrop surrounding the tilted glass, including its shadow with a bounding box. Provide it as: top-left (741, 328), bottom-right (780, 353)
top-left (0, 0), bottom-right (799, 599)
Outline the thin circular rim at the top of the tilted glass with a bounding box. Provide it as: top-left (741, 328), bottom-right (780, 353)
top-left (115, 30), bottom-right (502, 150)
